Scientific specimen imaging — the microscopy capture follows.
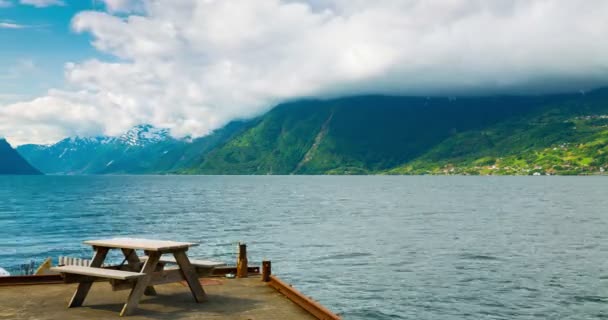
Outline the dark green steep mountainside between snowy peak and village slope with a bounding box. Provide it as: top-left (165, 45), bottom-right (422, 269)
top-left (189, 96), bottom-right (562, 174)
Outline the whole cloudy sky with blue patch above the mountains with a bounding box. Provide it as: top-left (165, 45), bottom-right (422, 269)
top-left (0, 0), bottom-right (608, 146)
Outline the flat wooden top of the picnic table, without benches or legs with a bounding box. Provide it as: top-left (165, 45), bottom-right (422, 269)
top-left (84, 238), bottom-right (198, 251)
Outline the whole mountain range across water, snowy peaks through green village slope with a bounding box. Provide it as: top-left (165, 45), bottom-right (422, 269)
top-left (13, 89), bottom-right (608, 175)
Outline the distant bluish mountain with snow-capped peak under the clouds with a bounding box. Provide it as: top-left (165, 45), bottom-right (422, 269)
top-left (17, 122), bottom-right (249, 174)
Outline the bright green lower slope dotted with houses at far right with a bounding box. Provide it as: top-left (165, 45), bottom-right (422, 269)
top-left (389, 90), bottom-right (608, 175)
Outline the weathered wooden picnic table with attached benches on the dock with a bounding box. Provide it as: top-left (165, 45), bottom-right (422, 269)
top-left (51, 238), bottom-right (224, 316)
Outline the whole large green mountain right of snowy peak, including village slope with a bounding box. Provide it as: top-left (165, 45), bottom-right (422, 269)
top-left (185, 89), bottom-right (608, 175)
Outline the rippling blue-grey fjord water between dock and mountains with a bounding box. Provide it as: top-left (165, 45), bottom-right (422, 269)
top-left (0, 176), bottom-right (608, 320)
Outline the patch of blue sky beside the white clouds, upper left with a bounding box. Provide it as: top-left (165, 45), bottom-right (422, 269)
top-left (0, 0), bottom-right (103, 103)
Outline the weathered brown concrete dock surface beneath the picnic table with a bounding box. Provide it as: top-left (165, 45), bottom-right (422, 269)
top-left (0, 277), bottom-right (314, 320)
